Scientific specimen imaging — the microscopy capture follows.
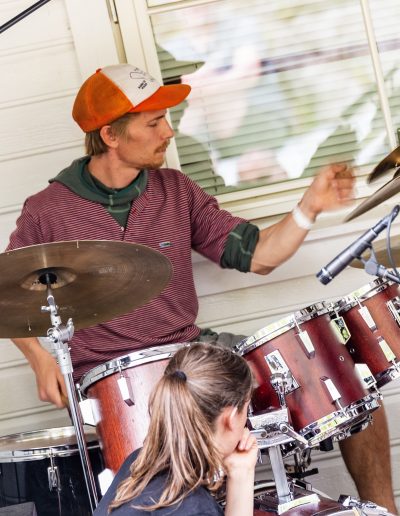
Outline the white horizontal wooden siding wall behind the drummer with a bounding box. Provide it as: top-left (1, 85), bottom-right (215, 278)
top-left (0, 0), bottom-right (400, 508)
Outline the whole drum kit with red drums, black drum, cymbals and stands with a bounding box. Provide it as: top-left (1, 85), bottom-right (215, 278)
top-left (0, 150), bottom-right (400, 516)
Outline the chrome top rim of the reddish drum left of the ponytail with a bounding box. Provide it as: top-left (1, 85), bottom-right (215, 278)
top-left (79, 342), bottom-right (193, 395)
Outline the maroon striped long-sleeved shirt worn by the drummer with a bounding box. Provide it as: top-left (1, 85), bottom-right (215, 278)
top-left (8, 169), bottom-right (244, 380)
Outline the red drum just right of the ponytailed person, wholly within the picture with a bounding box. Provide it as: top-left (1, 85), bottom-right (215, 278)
top-left (236, 303), bottom-right (379, 445)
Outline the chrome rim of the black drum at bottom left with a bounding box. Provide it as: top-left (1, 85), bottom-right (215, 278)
top-left (0, 426), bottom-right (99, 463)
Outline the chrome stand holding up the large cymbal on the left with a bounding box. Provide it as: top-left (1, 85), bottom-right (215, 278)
top-left (39, 272), bottom-right (98, 512)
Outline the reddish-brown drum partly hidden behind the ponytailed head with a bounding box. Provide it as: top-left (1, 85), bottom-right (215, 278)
top-left (80, 343), bottom-right (189, 473)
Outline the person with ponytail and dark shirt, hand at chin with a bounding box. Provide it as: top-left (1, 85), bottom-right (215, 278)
top-left (94, 343), bottom-right (257, 516)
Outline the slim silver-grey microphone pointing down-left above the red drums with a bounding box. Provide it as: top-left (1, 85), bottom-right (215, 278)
top-left (316, 205), bottom-right (400, 285)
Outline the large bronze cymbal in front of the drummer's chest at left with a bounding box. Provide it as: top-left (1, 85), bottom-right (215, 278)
top-left (0, 240), bottom-right (171, 338)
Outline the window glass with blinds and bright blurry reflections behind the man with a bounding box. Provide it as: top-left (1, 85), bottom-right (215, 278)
top-left (151, 0), bottom-right (400, 193)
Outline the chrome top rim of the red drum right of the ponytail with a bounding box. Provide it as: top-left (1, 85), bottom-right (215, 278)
top-left (234, 301), bottom-right (332, 356)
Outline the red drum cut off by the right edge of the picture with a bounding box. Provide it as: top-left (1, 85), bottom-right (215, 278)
top-left (336, 279), bottom-right (400, 387)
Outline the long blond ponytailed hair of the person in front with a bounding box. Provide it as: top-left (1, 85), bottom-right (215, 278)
top-left (110, 343), bottom-right (253, 511)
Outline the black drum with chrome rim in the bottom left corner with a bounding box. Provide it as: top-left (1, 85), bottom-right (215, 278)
top-left (0, 427), bottom-right (103, 516)
